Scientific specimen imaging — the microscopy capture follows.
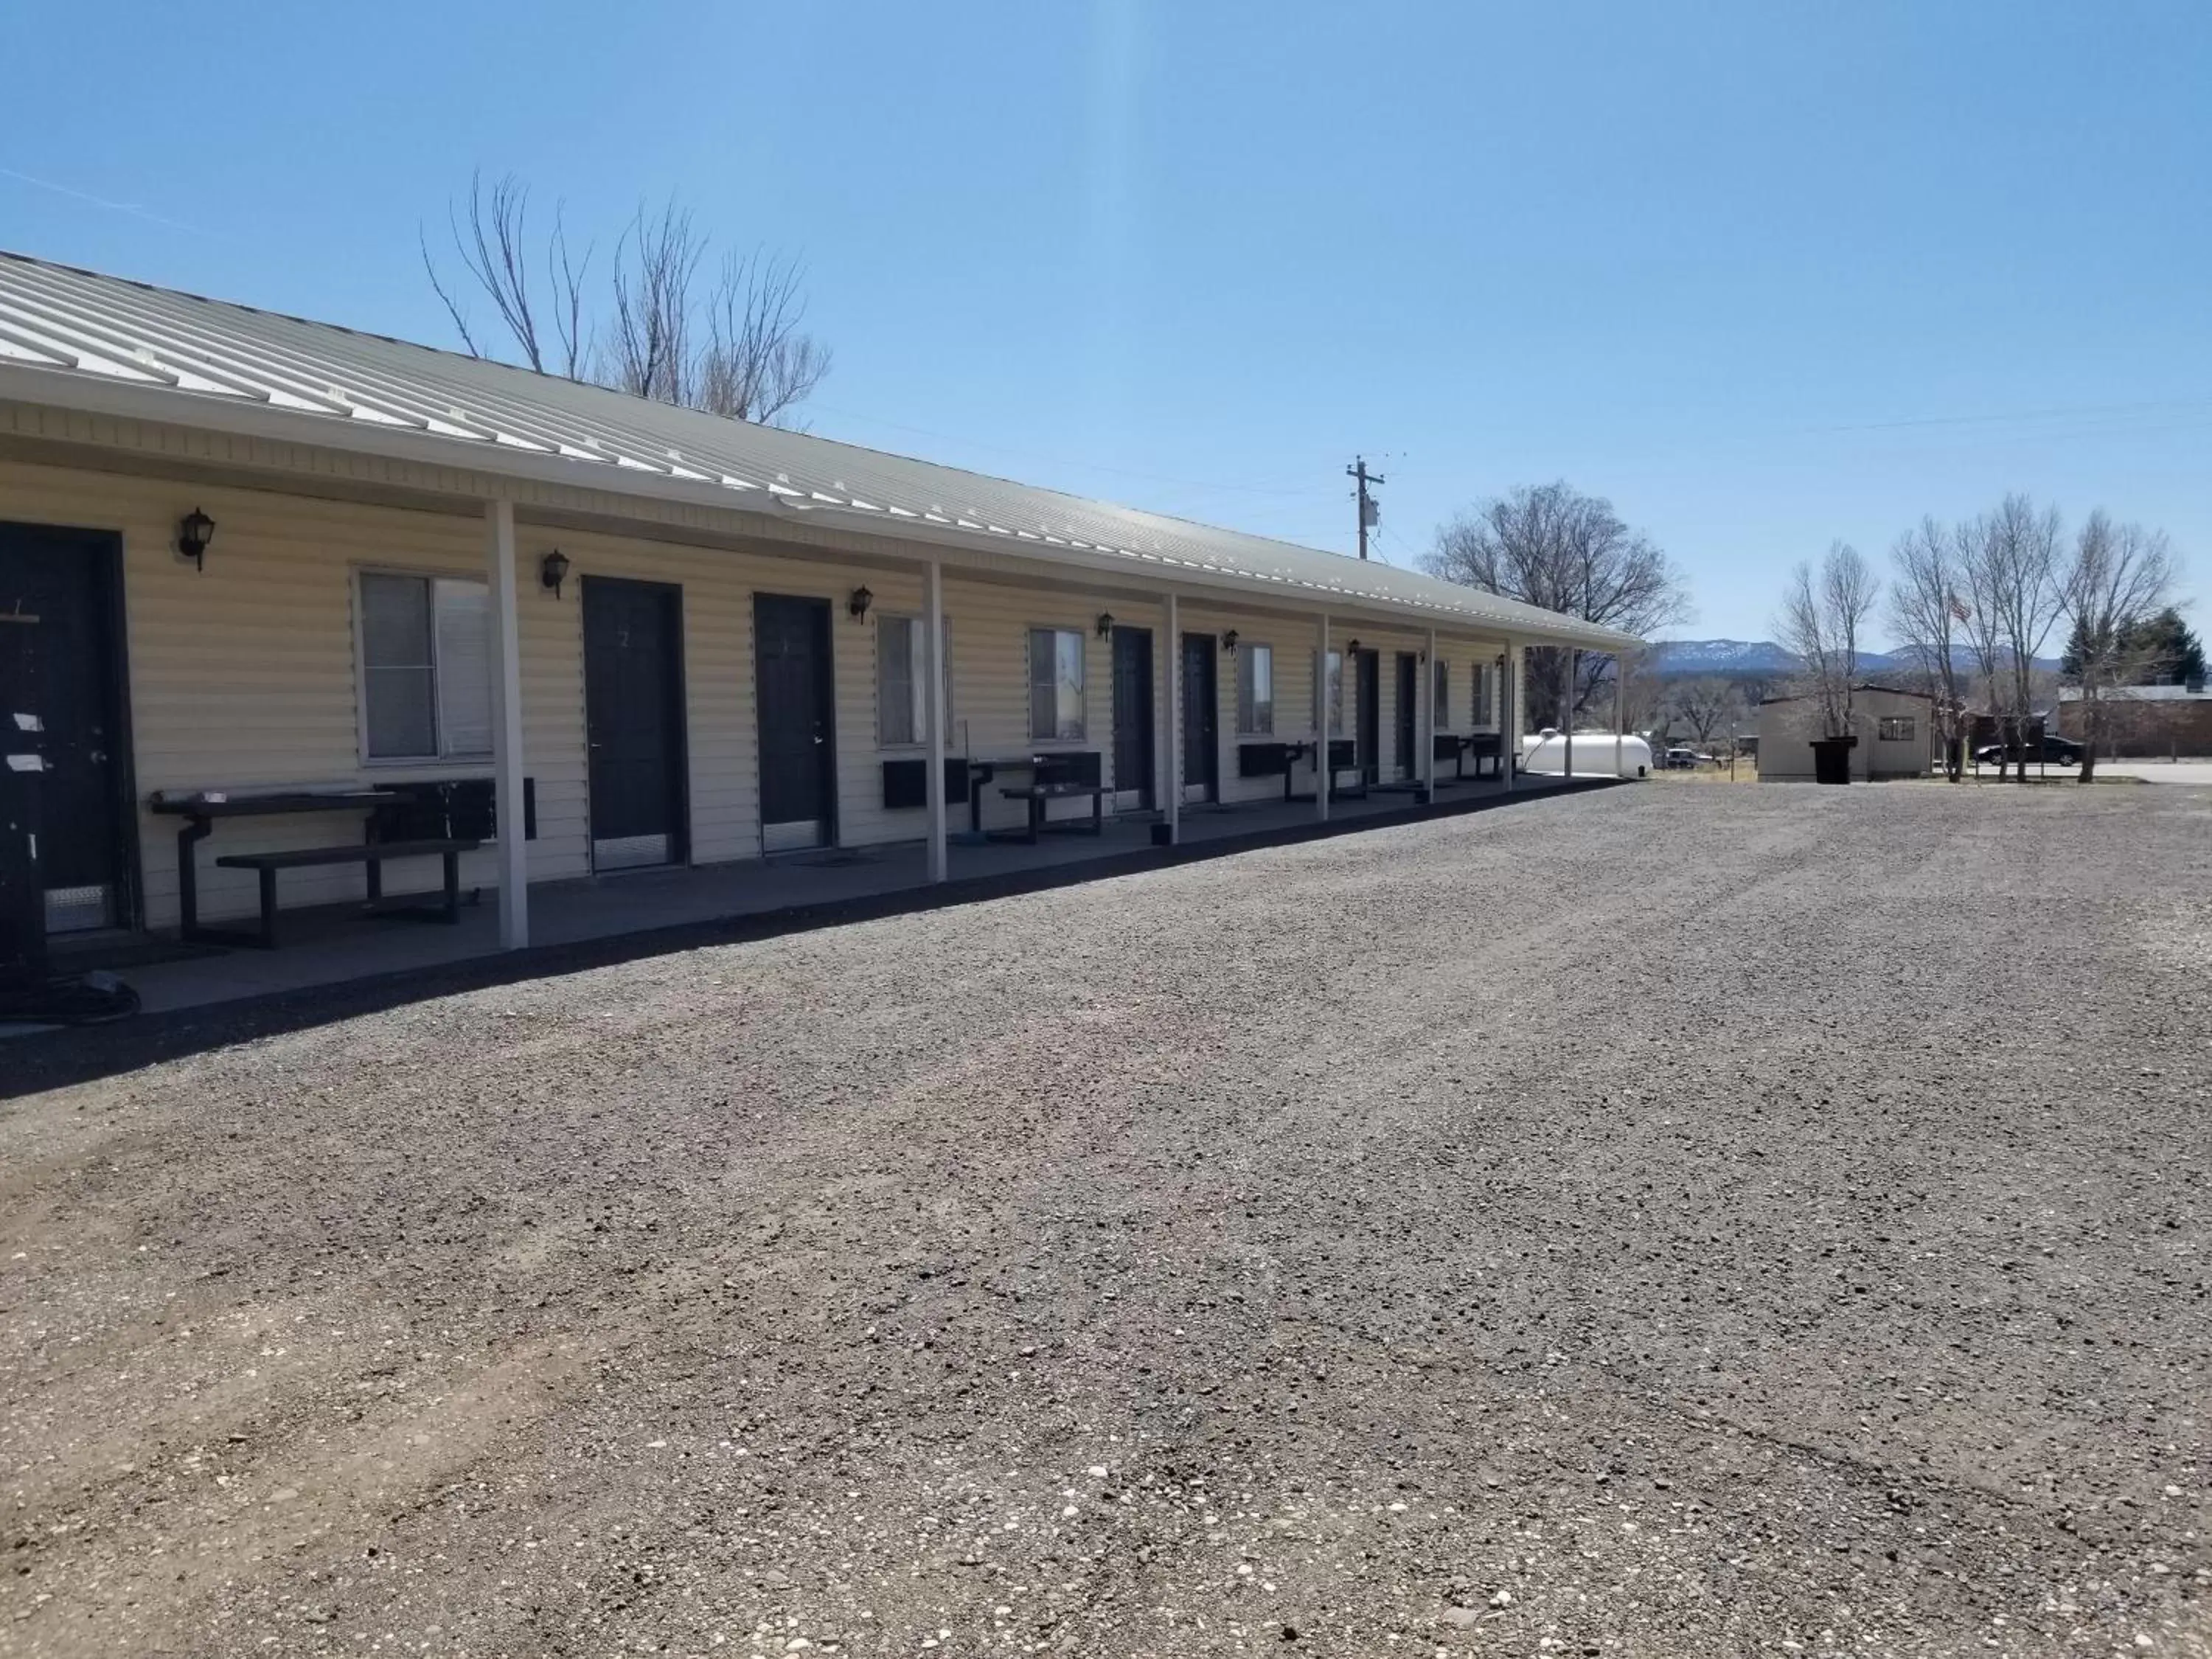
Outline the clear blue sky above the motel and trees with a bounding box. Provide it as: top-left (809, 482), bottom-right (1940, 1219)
top-left (0, 0), bottom-right (2212, 637)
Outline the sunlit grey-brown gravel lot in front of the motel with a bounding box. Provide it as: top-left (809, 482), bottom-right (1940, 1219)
top-left (0, 785), bottom-right (2212, 1659)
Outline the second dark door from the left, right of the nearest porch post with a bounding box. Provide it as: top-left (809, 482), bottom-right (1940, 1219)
top-left (582, 575), bottom-right (686, 869)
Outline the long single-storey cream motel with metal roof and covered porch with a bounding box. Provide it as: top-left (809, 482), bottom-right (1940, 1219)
top-left (0, 254), bottom-right (1635, 1000)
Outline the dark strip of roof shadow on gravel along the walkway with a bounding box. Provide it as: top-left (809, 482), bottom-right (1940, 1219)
top-left (0, 779), bottom-right (1617, 1099)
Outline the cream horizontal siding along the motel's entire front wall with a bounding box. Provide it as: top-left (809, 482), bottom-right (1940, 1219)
top-left (0, 442), bottom-right (1557, 927)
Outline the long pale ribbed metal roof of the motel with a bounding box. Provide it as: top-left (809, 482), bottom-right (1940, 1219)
top-left (0, 250), bottom-right (1635, 648)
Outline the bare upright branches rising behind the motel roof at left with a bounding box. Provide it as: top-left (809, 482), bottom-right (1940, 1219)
top-left (422, 173), bottom-right (832, 420)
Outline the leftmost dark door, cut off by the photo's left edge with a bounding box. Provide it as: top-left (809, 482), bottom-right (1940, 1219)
top-left (0, 524), bottom-right (133, 933)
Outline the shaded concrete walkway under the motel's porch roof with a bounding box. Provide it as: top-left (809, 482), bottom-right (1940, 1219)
top-left (58, 776), bottom-right (1582, 1013)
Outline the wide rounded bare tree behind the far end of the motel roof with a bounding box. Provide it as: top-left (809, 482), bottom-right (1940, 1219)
top-left (1422, 480), bottom-right (1690, 728)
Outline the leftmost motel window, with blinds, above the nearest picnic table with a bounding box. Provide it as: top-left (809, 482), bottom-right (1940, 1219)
top-left (358, 571), bottom-right (491, 761)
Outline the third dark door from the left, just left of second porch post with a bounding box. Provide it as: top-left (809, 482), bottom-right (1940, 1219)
top-left (752, 593), bottom-right (836, 852)
